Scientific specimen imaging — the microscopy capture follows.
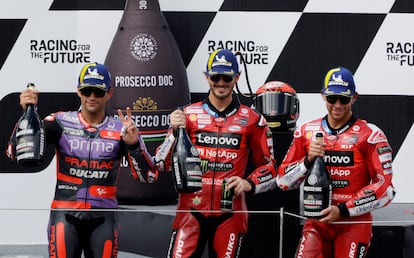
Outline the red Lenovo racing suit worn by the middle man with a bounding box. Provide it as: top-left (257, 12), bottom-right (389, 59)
top-left (155, 100), bottom-right (276, 257)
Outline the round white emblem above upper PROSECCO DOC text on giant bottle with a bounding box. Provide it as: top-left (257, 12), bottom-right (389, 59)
top-left (130, 33), bottom-right (158, 62)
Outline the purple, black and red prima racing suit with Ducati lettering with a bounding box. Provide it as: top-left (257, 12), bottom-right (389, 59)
top-left (7, 111), bottom-right (158, 258)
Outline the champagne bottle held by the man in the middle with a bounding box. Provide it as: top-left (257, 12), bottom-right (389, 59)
top-left (172, 126), bottom-right (202, 193)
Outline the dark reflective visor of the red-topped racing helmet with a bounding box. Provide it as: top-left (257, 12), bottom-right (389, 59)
top-left (255, 92), bottom-right (297, 117)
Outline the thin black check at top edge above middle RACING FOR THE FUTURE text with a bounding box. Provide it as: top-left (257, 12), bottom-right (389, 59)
top-left (220, 0), bottom-right (308, 12)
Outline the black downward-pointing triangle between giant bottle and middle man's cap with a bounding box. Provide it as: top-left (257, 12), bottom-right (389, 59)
top-left (164, 12), bottom-right (216, 67)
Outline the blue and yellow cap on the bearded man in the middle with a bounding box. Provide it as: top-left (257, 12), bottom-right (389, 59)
top-left (206, 49), bottom-right (239, 76)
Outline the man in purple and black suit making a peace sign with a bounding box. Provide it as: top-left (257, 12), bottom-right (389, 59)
top-left (7, 63), bottom-right (158, 258)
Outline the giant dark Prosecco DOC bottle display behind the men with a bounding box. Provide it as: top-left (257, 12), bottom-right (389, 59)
top-left (105, 0), bottom-right (190, 203)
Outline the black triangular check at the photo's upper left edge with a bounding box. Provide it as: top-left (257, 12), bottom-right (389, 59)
top-left (0, 19), bottom-right (27, 70)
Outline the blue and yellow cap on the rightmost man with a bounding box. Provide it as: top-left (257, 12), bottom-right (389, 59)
top-left (322, 66), bottom-right (355, 97)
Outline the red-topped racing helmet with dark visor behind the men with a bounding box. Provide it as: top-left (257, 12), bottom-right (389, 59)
top-left (253, 81), bottom-right (299, 131)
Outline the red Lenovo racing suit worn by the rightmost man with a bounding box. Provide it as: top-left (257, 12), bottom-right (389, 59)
top-left (276, 116), bottom-right (394, 257)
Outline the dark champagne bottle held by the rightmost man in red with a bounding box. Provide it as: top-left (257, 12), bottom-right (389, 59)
top-left (303, 132), bottom-right (332, 218)
